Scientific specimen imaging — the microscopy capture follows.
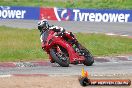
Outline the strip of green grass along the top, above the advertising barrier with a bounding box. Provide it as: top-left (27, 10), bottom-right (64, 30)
top-left (0, 0), bottom-right (132, 9)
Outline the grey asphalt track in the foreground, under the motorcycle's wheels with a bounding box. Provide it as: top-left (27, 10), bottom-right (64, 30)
top-left (0, 61), bottom-right (132, 76)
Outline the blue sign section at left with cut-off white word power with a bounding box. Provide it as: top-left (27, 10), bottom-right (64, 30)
top-left (0, 6), bottom-right (40, 20)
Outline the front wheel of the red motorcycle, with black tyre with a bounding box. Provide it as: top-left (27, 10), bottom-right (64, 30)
top-left (50, 46), bottom-right (70, 67)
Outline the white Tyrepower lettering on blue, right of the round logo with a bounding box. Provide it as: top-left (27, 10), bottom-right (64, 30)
top-left (73, 9), bottom-right (130, 22)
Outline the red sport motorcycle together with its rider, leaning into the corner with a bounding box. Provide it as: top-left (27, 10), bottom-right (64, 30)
top-left (38, 19), bottom-right (94, 67)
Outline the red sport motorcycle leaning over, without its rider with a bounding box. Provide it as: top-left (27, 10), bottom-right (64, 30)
top-left (44, 30), bottom-right (94, 67)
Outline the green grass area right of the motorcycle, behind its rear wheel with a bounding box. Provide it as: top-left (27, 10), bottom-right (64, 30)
top-left (77, 33), bottom-right (132, 56)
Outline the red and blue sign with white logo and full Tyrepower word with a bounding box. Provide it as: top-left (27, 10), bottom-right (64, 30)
top-left (40, 8), bottom-right (132, 22)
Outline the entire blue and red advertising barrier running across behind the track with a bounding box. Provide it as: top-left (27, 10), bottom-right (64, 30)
top-left (0, 6), bottom-right (132, 22)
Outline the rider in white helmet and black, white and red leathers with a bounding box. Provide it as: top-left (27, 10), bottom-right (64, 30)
top-left (38, 19), bottom-right (77, 50)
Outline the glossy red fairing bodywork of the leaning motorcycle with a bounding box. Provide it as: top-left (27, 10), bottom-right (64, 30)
top-left (42, 30), bottom-right (84, 63)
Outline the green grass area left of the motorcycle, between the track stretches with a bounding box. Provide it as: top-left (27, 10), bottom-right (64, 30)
top-left (0, 27), bottom-right (46, 61)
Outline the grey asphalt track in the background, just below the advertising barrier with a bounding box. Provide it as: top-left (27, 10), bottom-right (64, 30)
top-left (0, 19), bottom-right (132, 36)
